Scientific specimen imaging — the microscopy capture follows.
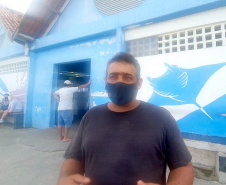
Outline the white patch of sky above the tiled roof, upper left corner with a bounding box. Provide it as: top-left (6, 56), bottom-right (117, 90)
top-left (0, 0), bottom-right (32, 13)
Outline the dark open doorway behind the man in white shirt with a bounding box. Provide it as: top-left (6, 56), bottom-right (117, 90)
top-left (54, 60), bottom-right (90, 125)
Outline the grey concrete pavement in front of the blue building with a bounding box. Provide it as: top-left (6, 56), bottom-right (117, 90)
top-left (0, 124), bottom-right (222, 185)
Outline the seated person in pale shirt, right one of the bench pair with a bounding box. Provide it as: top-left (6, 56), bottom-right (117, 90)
top-left (0, 95), bottom-right (23, 123)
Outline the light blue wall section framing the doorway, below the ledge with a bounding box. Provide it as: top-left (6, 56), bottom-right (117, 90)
top-left (27, 35), bottom-right (116, 129)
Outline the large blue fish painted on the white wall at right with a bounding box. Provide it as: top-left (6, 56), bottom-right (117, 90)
top-left (147, 63), bottom-right (226, 119)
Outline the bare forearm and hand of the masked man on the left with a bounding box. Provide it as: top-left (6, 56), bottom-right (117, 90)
top-left (57, 159), bottom-right (90, 185)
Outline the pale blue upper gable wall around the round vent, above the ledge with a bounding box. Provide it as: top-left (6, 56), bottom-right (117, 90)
top-left (49, 0), bottom-right (225, 35)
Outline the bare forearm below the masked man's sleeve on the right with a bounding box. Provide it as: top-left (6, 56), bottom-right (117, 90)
top-left (167, 162), bottom-right (194, 185)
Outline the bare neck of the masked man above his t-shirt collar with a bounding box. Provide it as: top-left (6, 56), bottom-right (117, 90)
top-left (107, 99), bottom-right (140, 112)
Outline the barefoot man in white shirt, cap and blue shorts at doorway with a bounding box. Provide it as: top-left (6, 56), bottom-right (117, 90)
top-left (53, 80), bottom-right (91, 141)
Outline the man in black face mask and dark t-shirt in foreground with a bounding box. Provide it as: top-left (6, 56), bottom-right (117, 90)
top-left (58, 53), bottom-right (194, 185)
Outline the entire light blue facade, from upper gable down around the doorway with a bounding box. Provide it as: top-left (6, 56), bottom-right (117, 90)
top-left (26, 0), bottom-right (226, 143)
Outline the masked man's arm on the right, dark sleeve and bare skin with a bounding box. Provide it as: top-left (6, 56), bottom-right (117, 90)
top-left (165, 112), bottom-right (194, 185)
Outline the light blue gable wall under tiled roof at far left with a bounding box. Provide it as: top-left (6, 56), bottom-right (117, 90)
top-left (0, 25), bottom-right (24, 60)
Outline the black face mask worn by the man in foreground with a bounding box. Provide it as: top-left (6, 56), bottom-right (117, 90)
top-left (105, 82), bottom-right (138, 105)
